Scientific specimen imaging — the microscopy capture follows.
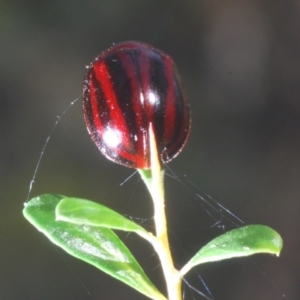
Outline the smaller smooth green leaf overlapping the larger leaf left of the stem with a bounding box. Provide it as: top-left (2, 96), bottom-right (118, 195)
top-left (55, 198), bottom-right (153, 242)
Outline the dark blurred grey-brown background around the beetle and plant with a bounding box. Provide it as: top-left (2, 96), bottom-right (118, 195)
top-left (0, 0), bottom-right (300, 300)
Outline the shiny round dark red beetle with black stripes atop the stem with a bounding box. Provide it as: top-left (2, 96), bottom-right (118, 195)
top-left (83, 42), bottom-right (190, 169)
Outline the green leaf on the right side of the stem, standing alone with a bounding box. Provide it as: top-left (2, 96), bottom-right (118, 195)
top-left (180, 225), bottom-right (283, 276)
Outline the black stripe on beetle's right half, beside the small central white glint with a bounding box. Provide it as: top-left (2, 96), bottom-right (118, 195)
top-left (149, 53), bottom-right (169, 152)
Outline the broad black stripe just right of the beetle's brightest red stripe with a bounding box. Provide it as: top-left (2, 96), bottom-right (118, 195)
top-left (105, 50), bottom-right (138, 151)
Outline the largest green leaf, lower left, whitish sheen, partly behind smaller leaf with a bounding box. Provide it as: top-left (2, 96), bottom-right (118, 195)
top-left (23, 194), bottom-right (166, 300)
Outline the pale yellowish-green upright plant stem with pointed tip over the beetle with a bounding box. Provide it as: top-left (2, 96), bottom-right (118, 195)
top-left (139, 124), bottom-right (182, 300)
